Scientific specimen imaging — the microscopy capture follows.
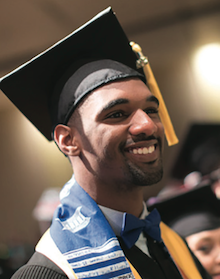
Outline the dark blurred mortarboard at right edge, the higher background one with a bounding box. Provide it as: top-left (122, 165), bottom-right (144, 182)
top-left (171, 123), bottom-right (220, 180)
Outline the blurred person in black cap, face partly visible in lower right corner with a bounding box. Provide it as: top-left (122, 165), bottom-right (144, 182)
top-left (148, 184), bottom-right (220, 279)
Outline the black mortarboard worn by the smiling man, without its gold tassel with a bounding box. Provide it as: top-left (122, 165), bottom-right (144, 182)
top-left (0, 8), bottom-right (145, 140)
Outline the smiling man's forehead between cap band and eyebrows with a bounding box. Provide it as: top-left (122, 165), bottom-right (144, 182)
top-left (82, 78), bottom-right (154, 109)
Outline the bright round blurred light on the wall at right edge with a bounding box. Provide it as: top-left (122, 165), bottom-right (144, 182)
top-left (195, 44), bottom-right (220, 88)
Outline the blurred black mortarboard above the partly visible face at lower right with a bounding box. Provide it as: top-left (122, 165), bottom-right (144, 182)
top-left (148, 184), bottom-right (220, 237)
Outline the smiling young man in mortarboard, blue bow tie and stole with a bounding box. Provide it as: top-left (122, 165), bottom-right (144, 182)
top-left (1, 9), bottom-right (209, 279)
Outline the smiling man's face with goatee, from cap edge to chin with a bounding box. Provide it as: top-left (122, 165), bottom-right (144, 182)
top-left (73, 79), bottom-right (164, 188)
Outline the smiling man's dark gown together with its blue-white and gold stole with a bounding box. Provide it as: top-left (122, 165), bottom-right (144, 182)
top-left (9, 177), bottom-right (211, 279)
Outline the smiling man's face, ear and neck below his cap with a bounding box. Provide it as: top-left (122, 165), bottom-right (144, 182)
top-left (54, 76), bottom-right (164, 217)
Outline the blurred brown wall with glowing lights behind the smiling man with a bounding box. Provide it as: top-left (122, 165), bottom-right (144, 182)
top-left (0, 0), bottom-right (220, 278)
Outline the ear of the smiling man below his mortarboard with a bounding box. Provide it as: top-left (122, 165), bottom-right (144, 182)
top-left (54, 124), bottom-right (80, 156)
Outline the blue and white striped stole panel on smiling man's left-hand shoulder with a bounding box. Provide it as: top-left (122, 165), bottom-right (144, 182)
top-left (36, 176), bottom-right (134, 279)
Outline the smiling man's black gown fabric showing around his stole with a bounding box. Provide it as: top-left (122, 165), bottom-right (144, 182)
top-left (12, 236), bottom-right (211, 279)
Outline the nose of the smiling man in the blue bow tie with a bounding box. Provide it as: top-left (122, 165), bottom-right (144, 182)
top-left (129, 109), bottom-right (157, 136)
